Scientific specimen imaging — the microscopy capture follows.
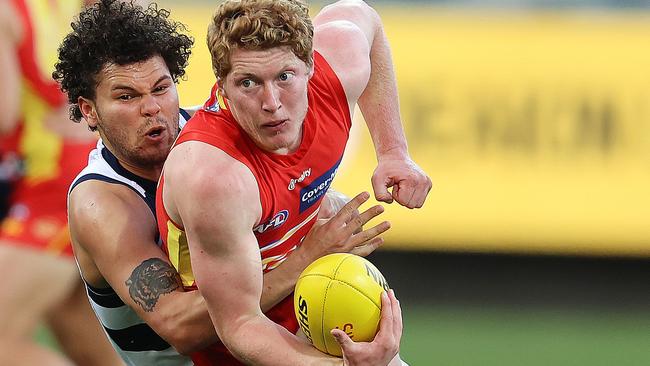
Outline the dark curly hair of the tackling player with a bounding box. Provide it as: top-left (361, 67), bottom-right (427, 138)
top-left (52, 0), bottom-right (194, 122)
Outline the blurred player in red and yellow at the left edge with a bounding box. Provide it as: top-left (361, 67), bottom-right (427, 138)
top-left (0, 0), bottom-right (121, 365)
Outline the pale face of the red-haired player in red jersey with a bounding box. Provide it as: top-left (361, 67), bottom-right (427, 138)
top-left (220, 47), bottom-right (312, 154)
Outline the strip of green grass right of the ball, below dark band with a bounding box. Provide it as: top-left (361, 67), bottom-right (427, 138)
top-left (401, 306), bottom-right (650, 366)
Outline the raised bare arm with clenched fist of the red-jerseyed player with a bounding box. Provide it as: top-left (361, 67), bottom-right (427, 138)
top-left (314, 0), bottom-right (431, 208)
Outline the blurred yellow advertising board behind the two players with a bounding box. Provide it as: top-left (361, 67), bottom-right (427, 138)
top-left (166, 3), bottom-right (650, 256)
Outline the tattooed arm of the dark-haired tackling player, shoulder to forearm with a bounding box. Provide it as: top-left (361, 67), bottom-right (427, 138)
top-left (68, 180), bottom-right (218, 353)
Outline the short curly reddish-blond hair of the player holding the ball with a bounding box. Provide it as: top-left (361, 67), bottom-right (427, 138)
top-left (207, 0), bottom-right (314, 79)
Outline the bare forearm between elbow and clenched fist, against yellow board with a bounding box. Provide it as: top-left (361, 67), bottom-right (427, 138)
top-left (358, 9), bottom-right (408, 159)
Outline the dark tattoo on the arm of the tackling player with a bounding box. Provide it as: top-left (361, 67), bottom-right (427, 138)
top-left (125, 258), bottom-right (182, 312)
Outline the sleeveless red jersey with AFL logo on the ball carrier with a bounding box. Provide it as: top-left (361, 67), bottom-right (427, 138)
top-left (156, 52), bottom-right (351, 365)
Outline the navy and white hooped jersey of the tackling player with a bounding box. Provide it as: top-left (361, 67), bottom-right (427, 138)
top-left (68, 109), bottom-right (193, 366)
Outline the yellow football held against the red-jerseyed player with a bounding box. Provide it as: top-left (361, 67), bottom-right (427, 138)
top-left (294, 253), bottom-right (388, 356)
